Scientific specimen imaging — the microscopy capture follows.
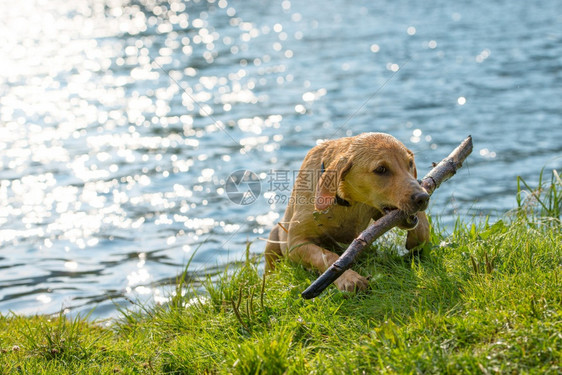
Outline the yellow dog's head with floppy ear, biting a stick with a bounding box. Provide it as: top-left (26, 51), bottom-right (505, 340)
top-left (315, 133), bottom-right (429, 214)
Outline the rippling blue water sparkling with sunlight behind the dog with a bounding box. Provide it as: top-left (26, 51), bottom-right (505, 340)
top-left (0, 0), bottom-right (562, 317)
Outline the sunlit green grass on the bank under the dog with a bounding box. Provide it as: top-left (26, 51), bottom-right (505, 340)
top-left (0, 173), bottom-right (562, 374)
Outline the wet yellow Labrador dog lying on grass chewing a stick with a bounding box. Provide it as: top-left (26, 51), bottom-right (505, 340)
top-left (265, 133), bottom-right (429, 291)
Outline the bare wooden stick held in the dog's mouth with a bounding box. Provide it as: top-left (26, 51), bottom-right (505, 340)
top-left (301, 135), bottom-right (472, 299)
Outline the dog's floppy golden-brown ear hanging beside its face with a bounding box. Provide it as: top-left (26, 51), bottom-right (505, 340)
top-left (314, 156), bottom-right (353, 211)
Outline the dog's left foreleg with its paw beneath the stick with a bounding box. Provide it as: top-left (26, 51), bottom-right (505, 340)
top-left (288, 240), bottom-right (369, 292)
